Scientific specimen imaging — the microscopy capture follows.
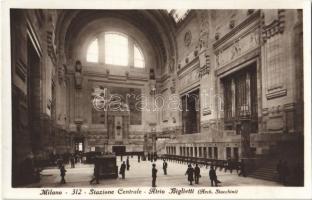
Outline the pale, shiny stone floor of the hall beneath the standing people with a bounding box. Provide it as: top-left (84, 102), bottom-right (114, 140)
top-left (27, 157), bottom-right (280, 187)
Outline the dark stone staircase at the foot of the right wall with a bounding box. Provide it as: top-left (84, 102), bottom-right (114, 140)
top-left (248, 160), bottom-right (279, 182)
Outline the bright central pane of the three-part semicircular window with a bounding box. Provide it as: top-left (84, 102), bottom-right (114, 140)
top-left (104, 33), bottom-right (129, 66)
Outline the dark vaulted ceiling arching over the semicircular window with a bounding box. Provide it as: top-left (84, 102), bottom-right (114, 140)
top-left (56, 10), bottom-right (177, 72)
